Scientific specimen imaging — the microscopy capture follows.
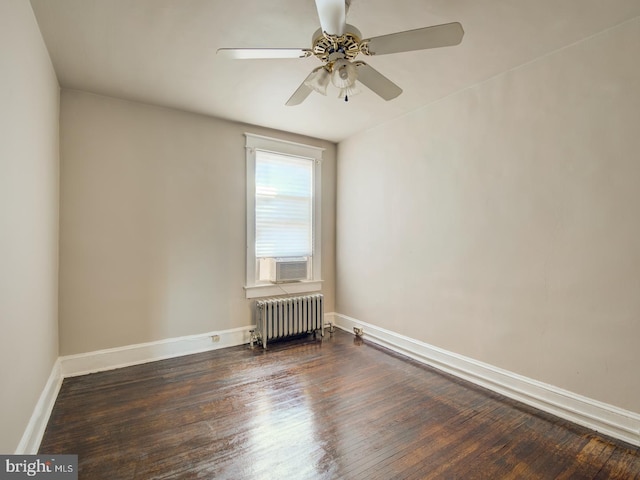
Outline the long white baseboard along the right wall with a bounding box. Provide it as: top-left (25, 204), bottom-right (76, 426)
top-left (326, 313), bottom-right (640, 446)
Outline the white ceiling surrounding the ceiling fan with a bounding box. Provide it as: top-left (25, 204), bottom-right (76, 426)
top-left (31, 0), bottom-right (640, 142)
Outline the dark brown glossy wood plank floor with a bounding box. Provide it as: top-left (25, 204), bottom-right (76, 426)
top-left (40, 331), bottom-right (640, 480)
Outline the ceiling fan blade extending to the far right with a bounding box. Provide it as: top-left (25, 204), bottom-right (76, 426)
top-left (365, 22), bottom-right (464, 55)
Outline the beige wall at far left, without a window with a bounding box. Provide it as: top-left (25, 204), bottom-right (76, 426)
top-left (0, 0), bottom-right (59, 453)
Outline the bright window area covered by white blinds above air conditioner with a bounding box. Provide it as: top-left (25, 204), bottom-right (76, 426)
top-left (256, 150), bottom-right (313, 258)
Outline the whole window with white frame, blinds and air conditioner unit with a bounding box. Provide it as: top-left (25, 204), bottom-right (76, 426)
top-left (245, 133), bottom-right (323, 298)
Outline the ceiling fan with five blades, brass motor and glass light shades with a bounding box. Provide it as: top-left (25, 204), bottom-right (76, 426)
top-left (217, 0), bottom-right (464, 106)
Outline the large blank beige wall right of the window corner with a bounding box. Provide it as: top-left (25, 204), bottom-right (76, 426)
top-left (336, 19), bottom-right (640, 412)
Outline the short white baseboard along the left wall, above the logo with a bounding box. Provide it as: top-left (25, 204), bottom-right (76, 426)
top-left (14, 358), bottom-right (62, 455)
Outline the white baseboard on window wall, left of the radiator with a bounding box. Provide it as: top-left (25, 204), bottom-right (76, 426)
top-left (59, 326), bottom-right (255, 378)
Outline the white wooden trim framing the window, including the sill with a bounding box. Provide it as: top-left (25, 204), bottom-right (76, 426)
top-left (244, 133), bottom-right (324, 298)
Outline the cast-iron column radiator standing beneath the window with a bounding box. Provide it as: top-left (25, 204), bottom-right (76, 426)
top-left (251, 294), bottom-right (324, 348)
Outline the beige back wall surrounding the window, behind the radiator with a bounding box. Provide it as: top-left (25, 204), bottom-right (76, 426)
top-left (60, 90), bottom-right (336, 355)
